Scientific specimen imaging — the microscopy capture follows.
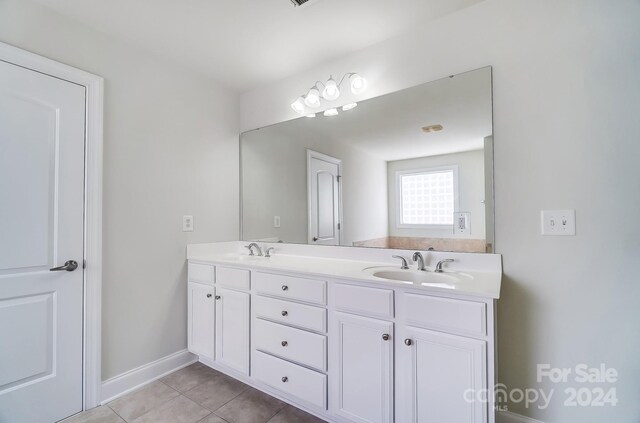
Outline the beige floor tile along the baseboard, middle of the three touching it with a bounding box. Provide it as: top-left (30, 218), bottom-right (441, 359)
top-left (108, 381), bottom-right (180, 421)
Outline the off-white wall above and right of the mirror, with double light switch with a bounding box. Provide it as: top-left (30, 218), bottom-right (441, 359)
top-left (241, 0), bottom-right (640, 423)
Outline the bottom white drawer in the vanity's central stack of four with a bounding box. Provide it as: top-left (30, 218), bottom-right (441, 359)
top-left (251, 351), bottom-right (327, 410)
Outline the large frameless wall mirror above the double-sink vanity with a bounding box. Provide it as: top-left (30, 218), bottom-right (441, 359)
top-left (240, 67), bottom-right (494, 252)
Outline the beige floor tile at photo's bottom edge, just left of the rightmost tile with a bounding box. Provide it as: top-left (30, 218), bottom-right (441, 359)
top-left (215, 388), bottom-right (285, 423)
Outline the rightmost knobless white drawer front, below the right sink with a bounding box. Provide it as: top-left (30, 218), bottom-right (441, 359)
top-left (403, 294), bottom-right (487, 336)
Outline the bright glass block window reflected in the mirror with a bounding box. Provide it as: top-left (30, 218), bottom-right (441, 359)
top-left (398, 167), bottom-right (458, 229)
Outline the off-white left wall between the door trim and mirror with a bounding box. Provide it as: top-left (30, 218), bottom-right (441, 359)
top-left (0, 0), bottom-right (238, 379)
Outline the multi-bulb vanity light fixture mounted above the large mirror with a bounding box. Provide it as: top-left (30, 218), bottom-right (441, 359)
top-left (291, 72), bottom-right (367, 116)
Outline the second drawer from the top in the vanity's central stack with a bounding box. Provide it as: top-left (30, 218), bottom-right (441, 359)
top-left (252, 295), bottom-right (327, 332)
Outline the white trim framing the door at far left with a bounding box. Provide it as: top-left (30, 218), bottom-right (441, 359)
top-left (0, 42), bottom-right (104, 410)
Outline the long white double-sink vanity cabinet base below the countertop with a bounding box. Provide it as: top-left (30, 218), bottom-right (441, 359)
top-left (188, 262), bottom-right (495, 423)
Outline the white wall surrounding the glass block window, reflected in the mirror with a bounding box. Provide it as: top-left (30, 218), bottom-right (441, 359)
top-left (387, 150), bottom-right (485, 239)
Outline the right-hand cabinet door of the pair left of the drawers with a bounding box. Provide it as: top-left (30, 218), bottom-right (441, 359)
top-left (216, 288), bottom-right (249, 374)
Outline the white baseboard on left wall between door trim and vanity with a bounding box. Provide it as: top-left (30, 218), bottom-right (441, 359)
top-left (100, 350), bottom-right (198, 404)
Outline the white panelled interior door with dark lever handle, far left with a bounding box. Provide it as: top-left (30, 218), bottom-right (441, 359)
top-left (0, 61), bottom-right (85, 422)
